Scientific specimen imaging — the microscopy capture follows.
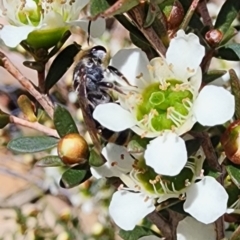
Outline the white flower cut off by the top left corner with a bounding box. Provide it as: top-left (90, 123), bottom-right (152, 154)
top-left (0, 0), bottom-right (105, 47)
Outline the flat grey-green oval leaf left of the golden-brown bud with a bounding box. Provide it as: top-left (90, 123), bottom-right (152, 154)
top-left (7, 136), bottom-right (59, 153)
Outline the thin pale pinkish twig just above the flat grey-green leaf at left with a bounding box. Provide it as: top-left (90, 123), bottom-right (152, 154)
top-left (9, 115), bottom-right (59, 138)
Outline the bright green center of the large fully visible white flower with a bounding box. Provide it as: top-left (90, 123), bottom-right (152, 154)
top-left (137, 79), bottom-right (193, 131)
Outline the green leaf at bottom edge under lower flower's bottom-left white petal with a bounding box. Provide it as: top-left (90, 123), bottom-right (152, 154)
top-left (119, 226), bottom-right (157, 240)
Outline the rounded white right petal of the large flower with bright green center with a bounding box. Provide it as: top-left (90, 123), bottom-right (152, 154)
top-left (193, 85), bottom-right (235, 126)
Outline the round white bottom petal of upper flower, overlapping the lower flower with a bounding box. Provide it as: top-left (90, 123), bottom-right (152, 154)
top-left (144, 132), bottom-right (187, 176)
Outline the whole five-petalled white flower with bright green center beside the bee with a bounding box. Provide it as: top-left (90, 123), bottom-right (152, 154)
top-left (93, 30), bottom-right (235, 176)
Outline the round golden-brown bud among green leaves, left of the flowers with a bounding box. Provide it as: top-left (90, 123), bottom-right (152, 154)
top-left (57, 133), bottom-right (89, 165)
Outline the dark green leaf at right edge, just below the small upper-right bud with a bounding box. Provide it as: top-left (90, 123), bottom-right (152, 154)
top-left (215, 43), bottom-right (240, 61)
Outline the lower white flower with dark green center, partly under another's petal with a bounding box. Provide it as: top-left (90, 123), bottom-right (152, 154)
top-left (91, 143), bottom-right (228, 230)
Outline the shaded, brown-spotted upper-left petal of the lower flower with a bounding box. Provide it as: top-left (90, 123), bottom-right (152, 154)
top-left (102, 143), bottom-right (134, 173)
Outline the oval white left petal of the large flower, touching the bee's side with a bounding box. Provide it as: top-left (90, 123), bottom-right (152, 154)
top-left (93, 103), bottom-right (136, 132)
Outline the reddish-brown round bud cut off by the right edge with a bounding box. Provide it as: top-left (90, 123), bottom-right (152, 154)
top-left (221, 120), bottom-right (240, 164)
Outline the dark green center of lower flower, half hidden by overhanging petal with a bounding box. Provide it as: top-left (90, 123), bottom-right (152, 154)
top-left (132, 158), bottom-right (195, 195)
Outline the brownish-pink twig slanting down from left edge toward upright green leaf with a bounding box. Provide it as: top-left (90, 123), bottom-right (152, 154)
top-left (0, 52), bottom-right (54, 118)
